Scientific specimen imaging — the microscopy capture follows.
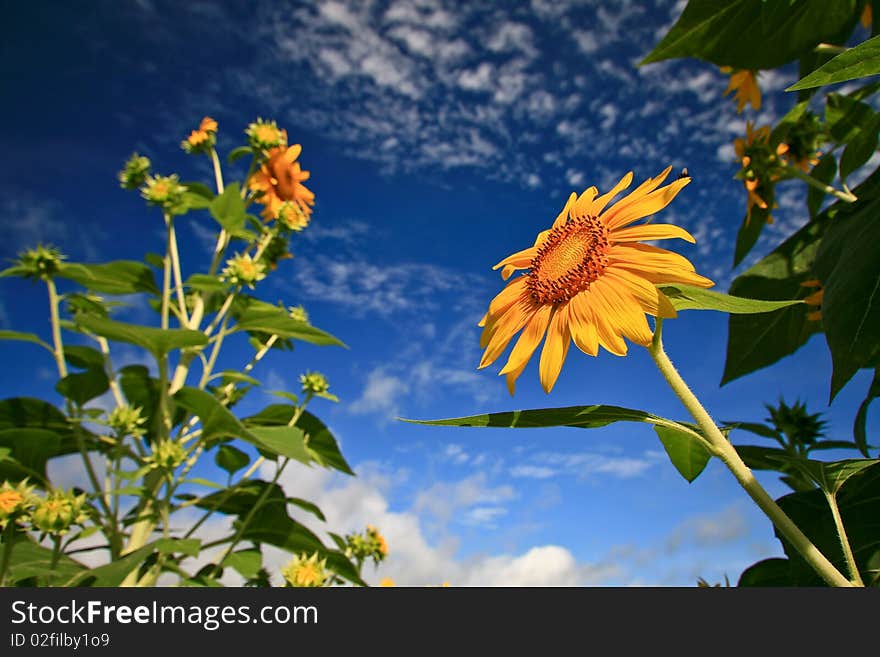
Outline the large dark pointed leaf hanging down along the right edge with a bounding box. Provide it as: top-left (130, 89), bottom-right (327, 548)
top-left (815, 176), bottom-right (880, 399)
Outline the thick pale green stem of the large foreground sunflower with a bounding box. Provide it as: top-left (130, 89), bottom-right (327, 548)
top-left (648, 318), bottom-right (853, 586)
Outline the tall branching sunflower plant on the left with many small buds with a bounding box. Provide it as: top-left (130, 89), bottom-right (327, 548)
top-left (0, 117), bottom-right (387, 586)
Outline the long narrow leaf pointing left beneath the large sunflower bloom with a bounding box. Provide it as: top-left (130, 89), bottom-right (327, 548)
top-left (399, 404), bottom-right (693, 432)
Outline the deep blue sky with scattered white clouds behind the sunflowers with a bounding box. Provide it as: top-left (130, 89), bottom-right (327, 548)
top-left (0, 0), bottom-right (868, 586)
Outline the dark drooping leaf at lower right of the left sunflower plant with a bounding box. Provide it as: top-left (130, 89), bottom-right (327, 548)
top-left (196, 480), bottom-right (363, 585)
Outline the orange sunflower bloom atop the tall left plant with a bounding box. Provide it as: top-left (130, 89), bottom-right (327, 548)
top-left (248, 144), bottom-right (315, 221)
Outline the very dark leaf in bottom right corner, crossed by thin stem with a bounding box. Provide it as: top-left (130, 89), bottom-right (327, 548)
top-left (776, 464), bottom-right (880, 586)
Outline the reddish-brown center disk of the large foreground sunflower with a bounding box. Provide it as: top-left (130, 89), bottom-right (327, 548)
top-left (527, 217), bottom-right (608, 303)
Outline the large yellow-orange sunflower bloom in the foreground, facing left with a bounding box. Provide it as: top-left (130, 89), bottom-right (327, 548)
top-left (479, 167), bottom-right (714, 394)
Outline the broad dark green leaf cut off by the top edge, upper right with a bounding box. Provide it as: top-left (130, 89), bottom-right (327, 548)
top-left (641, 0), bottom-right (858, 69)
